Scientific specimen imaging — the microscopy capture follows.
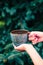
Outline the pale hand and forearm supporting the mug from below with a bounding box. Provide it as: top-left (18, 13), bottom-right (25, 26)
top-left (14, 44), bottom-right (43, 65)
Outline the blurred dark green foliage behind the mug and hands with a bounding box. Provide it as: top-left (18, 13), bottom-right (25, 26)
top-left (0, 0), bottom-right (43, 65)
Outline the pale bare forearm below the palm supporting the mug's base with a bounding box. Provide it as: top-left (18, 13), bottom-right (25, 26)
top-left (25, 44), bottom-right (43, 65)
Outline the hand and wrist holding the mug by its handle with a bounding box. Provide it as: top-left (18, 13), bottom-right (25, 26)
top-left (28, 31), bottom-right (43, 44)
